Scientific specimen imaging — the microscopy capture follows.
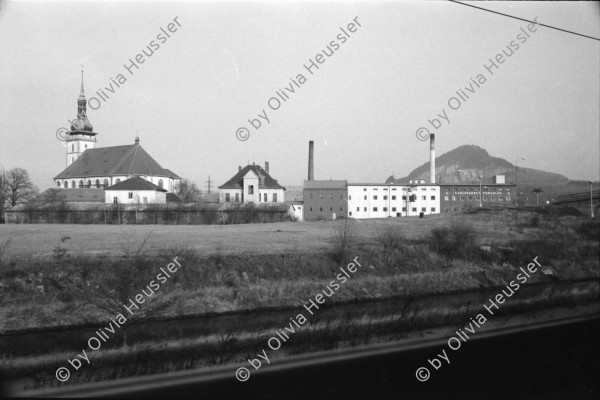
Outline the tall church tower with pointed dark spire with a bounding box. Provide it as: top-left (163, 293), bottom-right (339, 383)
top-left (66, 70), bottom-right (97, 167)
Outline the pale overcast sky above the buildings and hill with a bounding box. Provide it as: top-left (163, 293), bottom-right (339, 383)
top-left (0, 1), bottom-right (600, 189)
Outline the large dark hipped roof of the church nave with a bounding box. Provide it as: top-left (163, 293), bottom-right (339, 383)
top-left (54, 144), bottom-right (177, 179)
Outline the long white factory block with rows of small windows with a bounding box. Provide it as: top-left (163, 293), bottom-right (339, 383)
top-left (348, 183), bottom-right (440, 219)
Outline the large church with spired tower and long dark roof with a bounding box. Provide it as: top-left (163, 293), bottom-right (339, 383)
top-left (54, 71), bottom-right (181, 193)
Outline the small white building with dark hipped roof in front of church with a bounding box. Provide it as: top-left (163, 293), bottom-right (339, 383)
top-left (104, 176), bottom-right (167, 204)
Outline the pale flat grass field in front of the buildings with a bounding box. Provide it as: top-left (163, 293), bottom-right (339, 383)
top-left (0, 213), bottom-right (536, 256)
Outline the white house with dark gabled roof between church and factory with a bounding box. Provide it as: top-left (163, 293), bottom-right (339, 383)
top-left (219, 162), bottom-right (286, 204)
